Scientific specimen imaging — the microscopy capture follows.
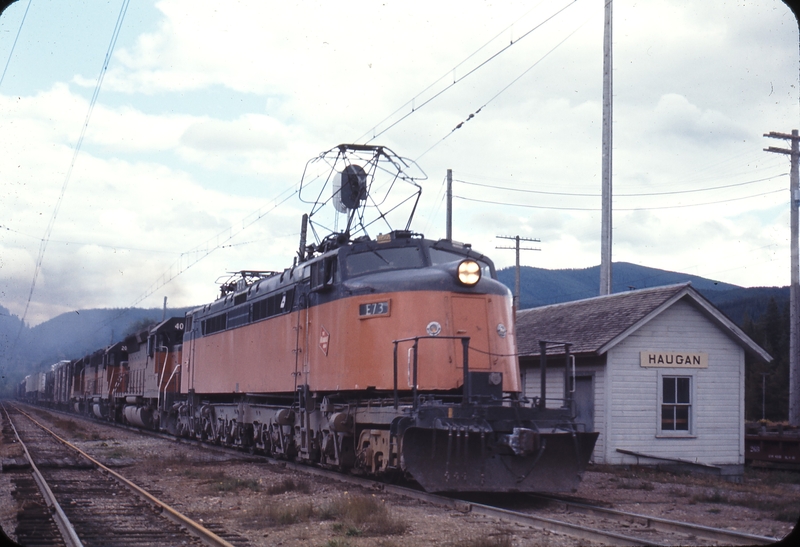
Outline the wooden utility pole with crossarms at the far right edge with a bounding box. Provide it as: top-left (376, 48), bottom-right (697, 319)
top-left (764, 129), bottom-right (800, 426)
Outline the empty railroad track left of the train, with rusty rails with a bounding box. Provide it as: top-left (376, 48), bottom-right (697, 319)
top-left (3, 405), bottom-right (241, 547)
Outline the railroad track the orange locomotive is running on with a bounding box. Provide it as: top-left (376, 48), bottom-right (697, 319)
top-left (4, 404), bottom-right (777, 545)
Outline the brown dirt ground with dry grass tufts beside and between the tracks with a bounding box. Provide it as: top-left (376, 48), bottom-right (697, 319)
top-left (0, 412), bottom-right (800, 547)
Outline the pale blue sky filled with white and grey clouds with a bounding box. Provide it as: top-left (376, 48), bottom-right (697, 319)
top-left (0, 0), bottom-right (800, 325)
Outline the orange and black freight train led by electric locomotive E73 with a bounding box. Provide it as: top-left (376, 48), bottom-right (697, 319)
top-left (19, 145), bottom-right (597, 492)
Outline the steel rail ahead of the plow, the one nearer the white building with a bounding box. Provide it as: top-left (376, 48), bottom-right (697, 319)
top-left (530, 494), bottom-right (778, 545)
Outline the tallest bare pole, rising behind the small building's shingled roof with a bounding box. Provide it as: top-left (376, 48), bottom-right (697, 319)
top-left (600, 0), bottom-right (613, 296)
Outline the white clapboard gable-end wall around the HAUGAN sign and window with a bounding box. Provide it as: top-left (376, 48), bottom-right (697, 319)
top-left (608, 301), bottom-right (744, 464)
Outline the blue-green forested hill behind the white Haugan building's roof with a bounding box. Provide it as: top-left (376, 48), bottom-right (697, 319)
top-left (497, 262), bottom-right (789, 326)
